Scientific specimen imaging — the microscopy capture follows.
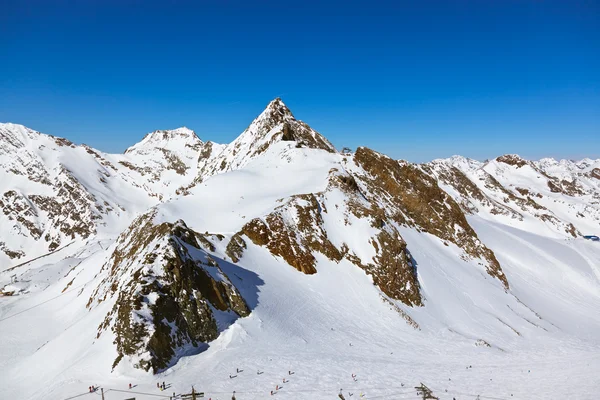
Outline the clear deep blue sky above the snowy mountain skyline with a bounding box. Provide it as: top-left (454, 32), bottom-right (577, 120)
top-left (0, 0), bottom-right (600, 161)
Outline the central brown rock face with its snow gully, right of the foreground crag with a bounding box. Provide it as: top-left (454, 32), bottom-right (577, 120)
top-left (228, 169), bottom-right (422, 306)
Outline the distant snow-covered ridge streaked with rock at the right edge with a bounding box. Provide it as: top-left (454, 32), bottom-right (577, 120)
top-left (424, 155), bottom-right (600, 234)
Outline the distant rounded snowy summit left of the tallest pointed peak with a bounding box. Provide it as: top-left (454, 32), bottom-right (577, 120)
top-left (125, 127), bottom-right (202, 154)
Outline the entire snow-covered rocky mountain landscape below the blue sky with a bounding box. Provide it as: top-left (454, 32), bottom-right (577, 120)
top-left (0, 99), bottom-right (600, 399)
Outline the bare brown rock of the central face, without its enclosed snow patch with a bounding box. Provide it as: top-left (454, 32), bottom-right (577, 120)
top-left (227, 169), bottom-right (422, 306)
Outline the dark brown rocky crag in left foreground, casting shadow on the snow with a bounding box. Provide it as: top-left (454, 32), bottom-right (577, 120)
top-left (88, 212), bottom-right (250, 373)
